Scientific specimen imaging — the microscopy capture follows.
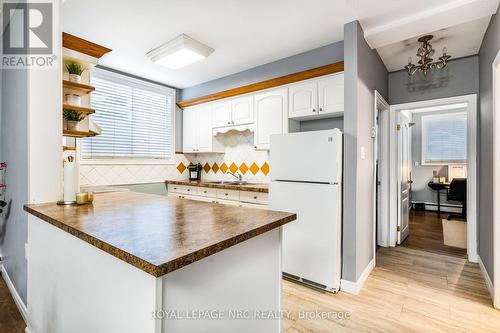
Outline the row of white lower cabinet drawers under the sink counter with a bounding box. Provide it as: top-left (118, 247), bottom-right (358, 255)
top-left (168, 184), bottom-right (268, 209)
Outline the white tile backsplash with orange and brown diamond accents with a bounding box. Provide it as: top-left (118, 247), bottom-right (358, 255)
top-left (80, 131), bottom-right (269, 186)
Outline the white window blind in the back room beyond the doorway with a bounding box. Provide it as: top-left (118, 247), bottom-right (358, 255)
top-left (422, 112), bottom-right (467, 164)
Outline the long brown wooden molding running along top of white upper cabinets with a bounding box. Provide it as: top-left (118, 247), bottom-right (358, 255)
top-left (177, 61), bottom-right (344, 108)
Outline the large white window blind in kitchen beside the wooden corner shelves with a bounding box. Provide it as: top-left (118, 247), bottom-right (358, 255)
top-left (82, 69), bottom-right (175, 160)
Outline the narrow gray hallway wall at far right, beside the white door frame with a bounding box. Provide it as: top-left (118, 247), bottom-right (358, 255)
top-left (478, 11), bottom-right (500, 281)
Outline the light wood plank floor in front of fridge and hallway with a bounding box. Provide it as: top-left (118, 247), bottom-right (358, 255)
top-left (283, 247), bottom-right (500, 333)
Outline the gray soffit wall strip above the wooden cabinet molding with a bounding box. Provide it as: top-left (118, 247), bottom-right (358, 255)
top-left (181, 42), bottom-right (344, 100)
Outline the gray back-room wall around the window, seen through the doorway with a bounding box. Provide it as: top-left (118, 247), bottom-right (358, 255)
top-left (411, 109), bottom-right (465, 205)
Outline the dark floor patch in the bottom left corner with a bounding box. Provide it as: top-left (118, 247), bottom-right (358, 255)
top-left (0, 277), bottom-right (26, 333)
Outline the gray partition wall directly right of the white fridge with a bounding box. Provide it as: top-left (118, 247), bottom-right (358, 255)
top-left (342, 21), bottom-right (388, 281)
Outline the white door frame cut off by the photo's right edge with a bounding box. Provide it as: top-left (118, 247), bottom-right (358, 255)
top-left (492, 51), bottom-right (500, 309)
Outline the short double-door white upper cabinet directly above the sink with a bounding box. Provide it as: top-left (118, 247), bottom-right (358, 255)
top-left (212, 95), bottom-right (254, 128)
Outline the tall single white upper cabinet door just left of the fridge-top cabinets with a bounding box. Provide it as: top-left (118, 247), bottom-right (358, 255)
top-left (255, 89), bottom-right (288, 149)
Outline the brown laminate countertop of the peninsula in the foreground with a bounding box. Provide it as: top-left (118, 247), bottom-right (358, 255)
top-left (24, 192), bottom-right (296, 277)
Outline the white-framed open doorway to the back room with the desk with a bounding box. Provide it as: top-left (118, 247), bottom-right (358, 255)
top-left (377, 95), bottom-right (477, 262)
